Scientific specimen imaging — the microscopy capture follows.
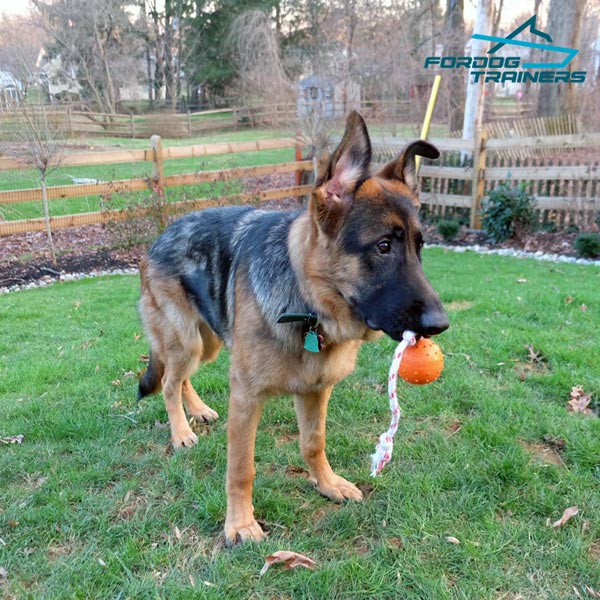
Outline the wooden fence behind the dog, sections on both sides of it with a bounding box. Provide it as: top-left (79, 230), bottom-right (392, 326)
top-left (0, 131), bottom-right (600, 235)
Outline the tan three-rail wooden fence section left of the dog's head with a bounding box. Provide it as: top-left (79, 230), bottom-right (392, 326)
top-left (0, 136), bottom-right (313, 236)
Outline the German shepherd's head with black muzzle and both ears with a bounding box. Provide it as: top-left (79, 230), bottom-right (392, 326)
top-left (309, 112), bottom-right (448, 340)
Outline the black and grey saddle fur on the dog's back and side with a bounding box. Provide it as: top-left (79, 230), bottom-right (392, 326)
top-left (147, 206), bottom-right (304, 345)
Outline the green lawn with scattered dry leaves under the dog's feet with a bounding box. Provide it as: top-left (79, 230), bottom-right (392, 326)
top-left (0, 249), bottom-right (600, 600)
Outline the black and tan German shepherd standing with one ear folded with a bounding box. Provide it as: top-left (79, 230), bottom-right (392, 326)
top-left (139, 112), bottom-right (448, 544)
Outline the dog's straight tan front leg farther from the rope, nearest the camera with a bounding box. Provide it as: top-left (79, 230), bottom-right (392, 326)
top-left (225, 378), bottom-right (265, 546)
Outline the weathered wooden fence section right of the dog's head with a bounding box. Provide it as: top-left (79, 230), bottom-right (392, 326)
top-left (374, 130), bottom-right (600, 229)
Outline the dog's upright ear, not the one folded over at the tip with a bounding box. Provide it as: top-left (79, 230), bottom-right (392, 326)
top-left (313, 111), bottom-right (371, 237)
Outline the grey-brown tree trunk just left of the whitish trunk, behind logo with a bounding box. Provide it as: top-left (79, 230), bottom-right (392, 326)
top-left (444, 0), bottom-right (465, 131)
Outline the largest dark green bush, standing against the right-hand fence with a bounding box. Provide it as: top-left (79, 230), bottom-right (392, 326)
top-left (482, 183), bottom-right (536, 242)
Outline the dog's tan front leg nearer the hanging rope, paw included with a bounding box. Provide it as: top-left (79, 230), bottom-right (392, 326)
top-left (294, 387), bottom-right (362, 502)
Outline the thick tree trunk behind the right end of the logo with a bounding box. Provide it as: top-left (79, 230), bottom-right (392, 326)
top-left (537, 0), bottom-right (585, 117)
